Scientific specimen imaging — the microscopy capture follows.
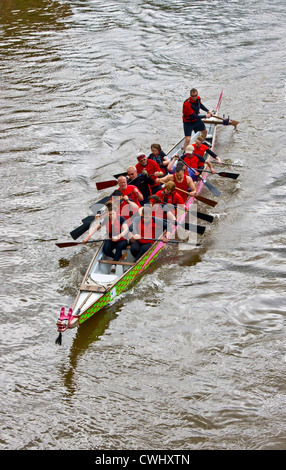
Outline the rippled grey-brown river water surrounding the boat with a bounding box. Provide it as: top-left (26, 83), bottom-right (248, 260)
top-left (0, 0), bottom-right (286, 451)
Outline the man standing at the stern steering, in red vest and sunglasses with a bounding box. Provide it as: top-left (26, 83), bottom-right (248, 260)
top-left (183, 88), bottom-right (213, 150)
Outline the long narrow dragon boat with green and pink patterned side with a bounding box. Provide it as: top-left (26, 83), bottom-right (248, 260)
top-left (56, 92), bottom-right (222, 344)
